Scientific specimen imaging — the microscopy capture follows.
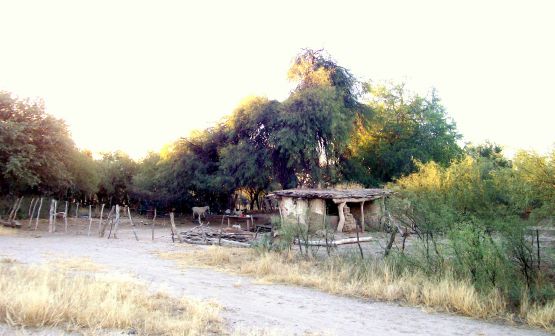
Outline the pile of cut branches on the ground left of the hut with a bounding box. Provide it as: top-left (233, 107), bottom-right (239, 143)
top-left (179, 225), bottom-right (254, 247)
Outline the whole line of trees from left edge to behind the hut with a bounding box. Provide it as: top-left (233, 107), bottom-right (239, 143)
top-left (0, 49), bottom-right (470, 209)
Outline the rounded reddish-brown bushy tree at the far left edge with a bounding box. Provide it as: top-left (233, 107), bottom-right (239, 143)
top-left (0, 92), bottom-right (96, 195)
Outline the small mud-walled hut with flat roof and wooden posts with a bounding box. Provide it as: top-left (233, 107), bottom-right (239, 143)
top-left (273, 189), bottom-right (391, 232)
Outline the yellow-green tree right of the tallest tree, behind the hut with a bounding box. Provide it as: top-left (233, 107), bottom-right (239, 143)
top-left (345, 84), bottom-right (462, 185)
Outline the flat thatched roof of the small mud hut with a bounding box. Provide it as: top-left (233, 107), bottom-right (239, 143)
top-left (274, 189), bottom-right (392, 201)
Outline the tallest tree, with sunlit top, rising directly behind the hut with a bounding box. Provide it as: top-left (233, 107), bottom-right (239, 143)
top-left (272, 50), bottom-right (371, 187)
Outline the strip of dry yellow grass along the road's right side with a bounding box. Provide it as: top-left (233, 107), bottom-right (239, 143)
top-left (161, 247), bottom-right (555, 330)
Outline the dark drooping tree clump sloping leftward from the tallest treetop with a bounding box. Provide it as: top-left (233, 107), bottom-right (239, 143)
top-left (142, 50), bottom-right (378, 209)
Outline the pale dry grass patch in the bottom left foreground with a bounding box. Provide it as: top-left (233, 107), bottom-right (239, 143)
top-left (0, 262), bottom-right (222, 335)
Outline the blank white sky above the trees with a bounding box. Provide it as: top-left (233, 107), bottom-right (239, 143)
top-left (0, 0), bottom-right (555, 158)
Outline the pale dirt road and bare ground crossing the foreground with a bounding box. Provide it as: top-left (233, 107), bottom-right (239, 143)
top-left (0, 219), bottom-right (547, 335)
